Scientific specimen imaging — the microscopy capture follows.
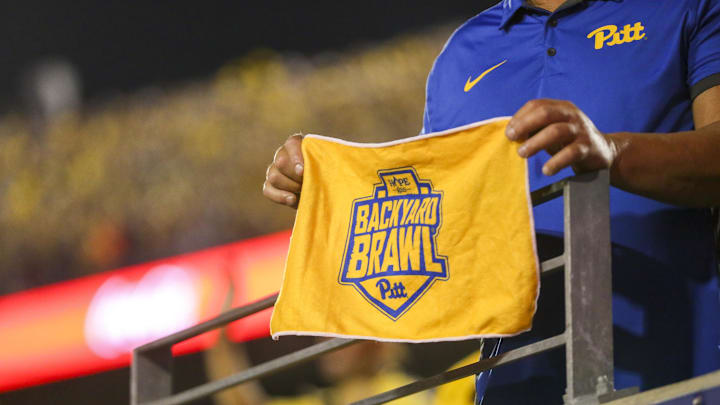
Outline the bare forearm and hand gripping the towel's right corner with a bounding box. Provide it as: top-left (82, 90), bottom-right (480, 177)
top-left (507, 86), bottom-right (720, 206)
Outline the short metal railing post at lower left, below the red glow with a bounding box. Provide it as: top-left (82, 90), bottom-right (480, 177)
top-left (130, 346), bottom-right (173, 405)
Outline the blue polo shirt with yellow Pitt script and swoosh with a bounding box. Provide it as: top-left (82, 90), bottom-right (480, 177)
top-left (423, 0), bottom-right (720, 398)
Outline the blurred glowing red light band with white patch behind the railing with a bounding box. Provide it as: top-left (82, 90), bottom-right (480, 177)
top-left (0, 232), bottom-right (290, 391)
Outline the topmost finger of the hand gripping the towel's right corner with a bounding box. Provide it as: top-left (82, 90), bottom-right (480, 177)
top-left (505, 100), bottom-right (574, 142)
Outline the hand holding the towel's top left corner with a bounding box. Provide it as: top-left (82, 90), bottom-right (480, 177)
top-left (263, 134), bottom-right (304, 208)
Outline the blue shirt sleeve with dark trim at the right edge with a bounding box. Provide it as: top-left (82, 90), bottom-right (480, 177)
top-left (687, 0), bottom-right (720, 100)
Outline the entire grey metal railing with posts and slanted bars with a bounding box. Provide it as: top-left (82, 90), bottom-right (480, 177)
top-left (130, 170), bottom-right (633, 405)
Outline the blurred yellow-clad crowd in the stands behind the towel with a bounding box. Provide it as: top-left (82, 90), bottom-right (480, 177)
top-left (0, 27), bottom-right (450, 294)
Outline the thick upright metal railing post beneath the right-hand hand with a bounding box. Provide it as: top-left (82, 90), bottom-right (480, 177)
top-left (564, 170), bottom-right (613, 405)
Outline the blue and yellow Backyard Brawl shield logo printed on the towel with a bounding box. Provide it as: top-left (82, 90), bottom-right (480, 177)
top-left (338, 167), bottom-right (449, 320)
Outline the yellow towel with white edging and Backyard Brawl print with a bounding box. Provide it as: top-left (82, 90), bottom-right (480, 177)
top-left (270, 118), bottom-right (539, 342)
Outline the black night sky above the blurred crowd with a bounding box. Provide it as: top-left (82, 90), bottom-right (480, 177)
top-left (0, 0), bottom-right (497, 110)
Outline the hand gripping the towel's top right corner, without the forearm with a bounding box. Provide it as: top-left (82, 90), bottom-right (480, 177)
top-left (505, 99), bottom-right (617, 176)
